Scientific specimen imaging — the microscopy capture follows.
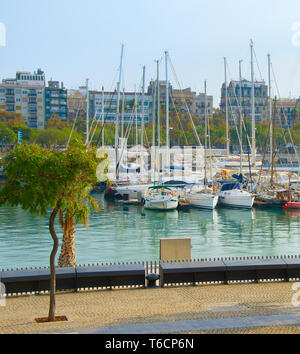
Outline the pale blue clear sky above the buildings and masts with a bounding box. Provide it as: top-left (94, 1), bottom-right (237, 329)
top-left (0, 0), bottom-right (300, 107)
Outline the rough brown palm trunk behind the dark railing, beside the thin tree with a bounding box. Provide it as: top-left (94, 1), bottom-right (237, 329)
top-left (58, 215), bottom-right (76, 268)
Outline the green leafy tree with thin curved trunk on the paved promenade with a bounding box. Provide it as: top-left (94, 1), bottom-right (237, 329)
top-left (0, 142), bottom-right (104, 321)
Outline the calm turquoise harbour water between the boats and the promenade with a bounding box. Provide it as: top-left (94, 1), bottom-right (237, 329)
top-left (0, 195), bottom-right (300, 269)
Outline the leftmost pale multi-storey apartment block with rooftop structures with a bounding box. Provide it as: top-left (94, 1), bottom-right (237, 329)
top-left (0, 69), bottom-right (45, 129)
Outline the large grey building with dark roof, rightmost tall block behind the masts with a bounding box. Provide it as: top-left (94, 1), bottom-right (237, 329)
top-left (220, 79), bottom-right (269, 126)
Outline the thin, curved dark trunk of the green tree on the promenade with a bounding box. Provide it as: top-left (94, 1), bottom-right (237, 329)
top-left (48, 208), bottom-right (59, 322)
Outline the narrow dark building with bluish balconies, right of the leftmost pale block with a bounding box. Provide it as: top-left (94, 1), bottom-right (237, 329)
top-left (45, 81), bottom-right (68, 122)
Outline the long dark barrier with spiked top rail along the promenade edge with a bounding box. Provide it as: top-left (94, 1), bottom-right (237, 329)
top-left (0, 255), bottom-right (300, 296)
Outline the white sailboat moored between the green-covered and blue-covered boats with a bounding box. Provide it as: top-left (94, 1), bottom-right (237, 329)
top-left (186, 81), bottom-right (219, 210)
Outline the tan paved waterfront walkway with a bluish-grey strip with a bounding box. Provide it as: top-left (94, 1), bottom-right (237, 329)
top-left (0, 282), bottom-right (300, 334)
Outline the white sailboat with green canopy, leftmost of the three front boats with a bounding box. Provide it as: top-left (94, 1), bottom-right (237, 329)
top-left (144, 57), bottom-right (178, 210)
